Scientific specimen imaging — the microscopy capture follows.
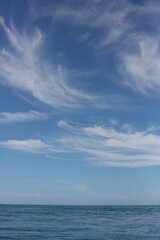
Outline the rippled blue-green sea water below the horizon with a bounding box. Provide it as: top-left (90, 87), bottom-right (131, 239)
top-left (0, 205), bottom-right (160, 240)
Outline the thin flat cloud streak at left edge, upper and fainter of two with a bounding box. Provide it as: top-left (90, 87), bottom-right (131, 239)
top-left (0, 111), bottom-right (49, 124)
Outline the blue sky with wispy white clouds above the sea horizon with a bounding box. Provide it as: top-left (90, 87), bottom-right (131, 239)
top-left (0, 0), bottom-right (160, 205)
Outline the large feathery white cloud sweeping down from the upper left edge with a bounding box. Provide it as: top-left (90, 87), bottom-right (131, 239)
top-left (0, 17), bottom-right (94, 108)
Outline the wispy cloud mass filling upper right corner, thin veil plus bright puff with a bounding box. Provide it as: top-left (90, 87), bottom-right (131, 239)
top-left (41, 0), bottom-right (160, 93)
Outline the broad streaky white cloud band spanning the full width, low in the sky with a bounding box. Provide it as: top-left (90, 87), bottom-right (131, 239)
top-left (0, 120), bottom-right (160, 167)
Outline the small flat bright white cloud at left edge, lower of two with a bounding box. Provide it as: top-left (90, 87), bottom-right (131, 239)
top-left (0, 139), bottom-right (50, 153)
